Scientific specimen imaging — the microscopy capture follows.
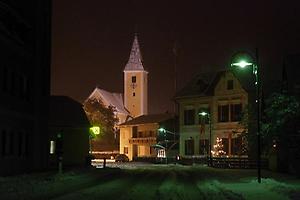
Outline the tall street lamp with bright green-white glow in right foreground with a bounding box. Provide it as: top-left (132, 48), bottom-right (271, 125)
top-left (231, 49), bottom-right (261, 183)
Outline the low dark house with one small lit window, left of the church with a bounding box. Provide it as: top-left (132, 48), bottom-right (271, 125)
top-left (48, 96), bottom-right (91, 167)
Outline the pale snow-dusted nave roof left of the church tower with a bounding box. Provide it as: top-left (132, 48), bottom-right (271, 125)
top-left (88, 87), bottom-right (129, 115)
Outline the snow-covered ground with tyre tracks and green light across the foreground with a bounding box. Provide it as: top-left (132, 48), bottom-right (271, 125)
top-left (0, 163), bottom-right (300, 200)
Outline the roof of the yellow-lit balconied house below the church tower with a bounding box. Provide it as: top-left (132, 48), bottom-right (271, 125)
top-left (120, 113), bottom-right (174, 126)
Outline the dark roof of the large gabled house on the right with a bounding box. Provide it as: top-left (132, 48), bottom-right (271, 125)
top-left (175, 70), bottom-right (254, 98)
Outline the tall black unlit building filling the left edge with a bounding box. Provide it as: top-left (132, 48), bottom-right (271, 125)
top-left (0, 0), bottom-right (51, 175)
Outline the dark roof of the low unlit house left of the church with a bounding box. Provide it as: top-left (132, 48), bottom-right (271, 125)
top-left (48, 96), bottom-right (90, 128)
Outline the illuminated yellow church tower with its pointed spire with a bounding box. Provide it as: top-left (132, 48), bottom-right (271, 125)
top-left (124, 35), bottom-right (148, 117)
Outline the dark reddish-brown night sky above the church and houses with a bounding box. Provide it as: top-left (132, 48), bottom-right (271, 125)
top-left (51, 0), bottom-right (300, 113)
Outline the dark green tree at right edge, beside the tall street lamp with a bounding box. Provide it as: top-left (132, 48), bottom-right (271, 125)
top-left (261, 93), bottom-right (300, 171)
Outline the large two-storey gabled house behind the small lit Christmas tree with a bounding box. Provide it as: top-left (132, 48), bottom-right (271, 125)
top-left (175, 71), bottom-right (252, 157)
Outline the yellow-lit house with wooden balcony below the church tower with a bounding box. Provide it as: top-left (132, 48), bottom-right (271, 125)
top-left (118, 114), bottom-right (177, 160)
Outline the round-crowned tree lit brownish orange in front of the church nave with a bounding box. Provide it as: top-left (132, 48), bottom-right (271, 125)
top-left (83, 99), bottom-right (118, 148)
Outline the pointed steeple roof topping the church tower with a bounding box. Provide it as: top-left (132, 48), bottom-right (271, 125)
top-left (124, 34), bottom-right (144, 71)
